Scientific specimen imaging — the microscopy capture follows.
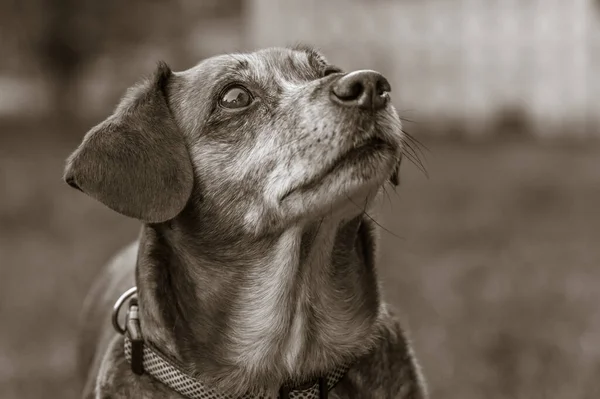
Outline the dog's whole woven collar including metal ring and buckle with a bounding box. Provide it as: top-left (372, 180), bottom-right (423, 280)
top-left (112, 287), bottom-right (350, 399)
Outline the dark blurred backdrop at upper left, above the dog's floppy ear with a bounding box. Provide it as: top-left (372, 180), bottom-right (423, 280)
top-left (0, 0), bottom-right (245, 119)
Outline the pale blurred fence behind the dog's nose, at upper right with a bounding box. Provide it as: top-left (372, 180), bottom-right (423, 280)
top-left (248, 0), bottom-right (600, 137)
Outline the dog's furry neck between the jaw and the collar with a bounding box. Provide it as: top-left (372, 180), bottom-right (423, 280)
top-left (136, 211), bottom-right (380, 395)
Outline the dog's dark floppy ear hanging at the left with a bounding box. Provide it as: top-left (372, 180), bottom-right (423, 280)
top-left (64, 63), bottom-right (193, 223)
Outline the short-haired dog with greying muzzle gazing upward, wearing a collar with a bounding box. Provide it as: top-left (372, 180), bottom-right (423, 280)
top-left (63, 46), bottom-right (427, 399)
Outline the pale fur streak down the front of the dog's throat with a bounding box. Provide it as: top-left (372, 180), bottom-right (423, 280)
top-left (233, 227), bottom-right (331, 373)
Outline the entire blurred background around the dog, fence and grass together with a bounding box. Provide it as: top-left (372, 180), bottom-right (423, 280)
top-left (0, 0), bottom-right (600, 399)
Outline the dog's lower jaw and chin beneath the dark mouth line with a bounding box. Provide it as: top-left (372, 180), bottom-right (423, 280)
top-left (279, 139), bottom-right (398, 222)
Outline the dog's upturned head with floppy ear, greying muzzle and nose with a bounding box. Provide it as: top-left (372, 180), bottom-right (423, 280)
top-left (65, 48), bottom-right (403, 234)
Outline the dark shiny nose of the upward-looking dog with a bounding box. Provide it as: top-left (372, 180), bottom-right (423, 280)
top-left (331, 71), bottom-right (392, 111)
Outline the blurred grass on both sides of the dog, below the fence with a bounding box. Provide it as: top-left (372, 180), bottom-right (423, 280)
top-left (0, 122), bottom-right (600, 399)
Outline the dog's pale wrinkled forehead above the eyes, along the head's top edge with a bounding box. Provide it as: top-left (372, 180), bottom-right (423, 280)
top-left (179, 46), bottom-right (327, 86)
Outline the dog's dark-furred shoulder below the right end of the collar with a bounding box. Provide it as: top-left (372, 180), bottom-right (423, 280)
top-left (334, 313), bottom-right (427, 399)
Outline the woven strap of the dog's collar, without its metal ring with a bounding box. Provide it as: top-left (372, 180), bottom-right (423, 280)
top-left (124, 334), bottom-right (348, 399)
